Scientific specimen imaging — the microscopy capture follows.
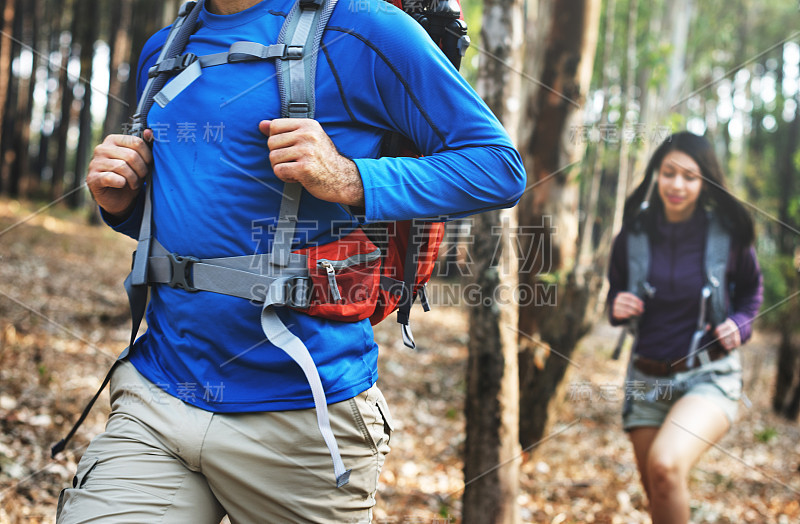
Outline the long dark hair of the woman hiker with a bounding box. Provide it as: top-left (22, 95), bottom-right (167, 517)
top-left (623, 131), bottom-right (755, 246)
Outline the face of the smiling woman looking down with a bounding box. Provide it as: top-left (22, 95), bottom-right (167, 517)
top-left (658, 151), bottom-right (703, 222)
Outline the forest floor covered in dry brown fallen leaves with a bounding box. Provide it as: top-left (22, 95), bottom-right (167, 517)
top-left (0, 199), bottom-right (800, 524)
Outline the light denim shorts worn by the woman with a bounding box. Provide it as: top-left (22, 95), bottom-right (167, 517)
top-left (622, 350), bottom-right (742, 431)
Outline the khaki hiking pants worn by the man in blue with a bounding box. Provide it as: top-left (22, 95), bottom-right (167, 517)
top-left (57, 362), bottom-right (391, 524)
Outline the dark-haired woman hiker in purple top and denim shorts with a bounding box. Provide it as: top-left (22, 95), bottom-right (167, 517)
top-left (607, 132), bottom-right (762, 524)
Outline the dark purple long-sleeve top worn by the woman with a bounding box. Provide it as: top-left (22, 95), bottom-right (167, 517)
top-left (607, 209), bottom-right (763, 360)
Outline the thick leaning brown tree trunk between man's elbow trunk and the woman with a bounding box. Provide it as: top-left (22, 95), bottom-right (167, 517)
top-left (519, 0), bottom-right (603, 447)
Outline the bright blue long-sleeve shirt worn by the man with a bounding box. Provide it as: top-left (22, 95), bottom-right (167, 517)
top-left (108, 0), bottom-right (525, 412)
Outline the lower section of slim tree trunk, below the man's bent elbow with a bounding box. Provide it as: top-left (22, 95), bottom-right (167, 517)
top-left (462, 210), bottom-right (521, 524)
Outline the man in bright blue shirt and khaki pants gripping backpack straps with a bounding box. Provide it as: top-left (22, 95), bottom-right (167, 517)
top-left (59, 0), bottom-right (525, 523)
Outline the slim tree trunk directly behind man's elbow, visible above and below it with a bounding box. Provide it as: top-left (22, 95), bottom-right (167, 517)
top-left (462, 0), bottom-right (523, 524)
